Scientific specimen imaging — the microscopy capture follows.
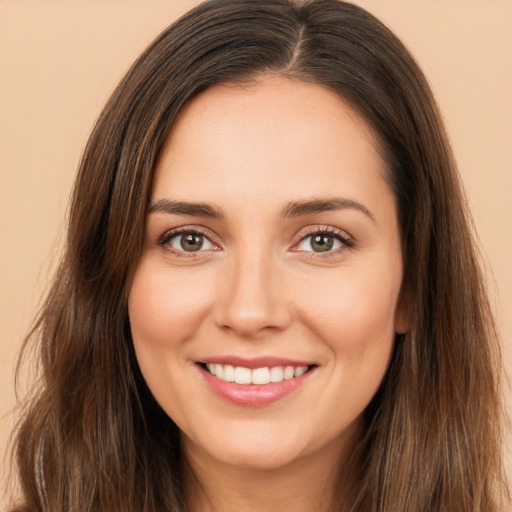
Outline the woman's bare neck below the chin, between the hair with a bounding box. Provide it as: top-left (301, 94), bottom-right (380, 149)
top-left (185, 432), bottom-right (358, 512)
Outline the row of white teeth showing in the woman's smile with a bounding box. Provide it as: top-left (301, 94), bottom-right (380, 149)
top-left (206, 363), bottom-right (308, 385)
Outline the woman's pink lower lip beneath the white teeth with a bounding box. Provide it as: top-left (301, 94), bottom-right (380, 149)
top-left (198, 365), bottom-right (315, 407)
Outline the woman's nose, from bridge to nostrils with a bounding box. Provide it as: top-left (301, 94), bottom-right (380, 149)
top-left (214, 251), bottom-right (292, 338)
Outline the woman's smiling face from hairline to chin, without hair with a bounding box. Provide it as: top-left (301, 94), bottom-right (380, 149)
top-left (129, 77), bottom-right (406, 468)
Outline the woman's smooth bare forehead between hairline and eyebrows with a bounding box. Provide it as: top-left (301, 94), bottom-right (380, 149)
top-left (153, 77), bottom-right (392, 217)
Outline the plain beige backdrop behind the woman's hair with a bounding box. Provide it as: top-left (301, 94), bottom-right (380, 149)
top-left (0, 0), bottom-right (512, 509)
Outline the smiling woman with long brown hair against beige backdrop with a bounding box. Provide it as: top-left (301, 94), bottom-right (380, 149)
top-left (10, 0), bottom-right (505, 512)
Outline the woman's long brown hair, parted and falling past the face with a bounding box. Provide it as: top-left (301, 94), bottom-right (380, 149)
top-left (10, 0), bottom-right (505, 512)
